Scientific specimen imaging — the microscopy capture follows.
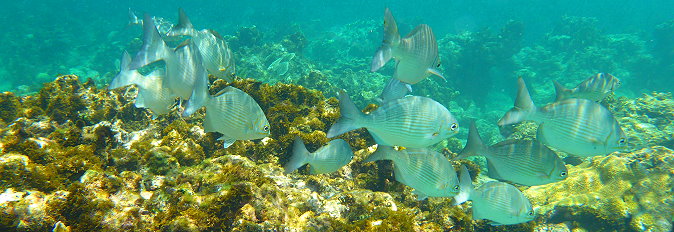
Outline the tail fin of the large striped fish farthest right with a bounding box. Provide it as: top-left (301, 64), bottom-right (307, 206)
top-left (498, 77), bottom-right (536, 126)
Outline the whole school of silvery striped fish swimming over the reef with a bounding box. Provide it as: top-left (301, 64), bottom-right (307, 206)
top-left (108, 8), bottom-right (627, 225)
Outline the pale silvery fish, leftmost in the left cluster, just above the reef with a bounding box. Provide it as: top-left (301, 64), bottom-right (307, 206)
top-left (108, 51), bottom-right (175, 118)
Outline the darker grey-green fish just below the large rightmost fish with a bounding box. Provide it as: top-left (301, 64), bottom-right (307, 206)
top-left (457, 122), bottom-right (568, 186)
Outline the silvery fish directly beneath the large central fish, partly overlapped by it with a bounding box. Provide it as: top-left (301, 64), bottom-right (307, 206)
top-left (363, 146), bottom-right (459, 200)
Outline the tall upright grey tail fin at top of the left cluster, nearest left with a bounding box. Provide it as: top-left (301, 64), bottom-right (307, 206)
top-left (129, 14), bottom-right (173, 69)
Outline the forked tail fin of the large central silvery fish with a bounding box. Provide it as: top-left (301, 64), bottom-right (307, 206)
top-left (328, 90), bottom-right (364, 138)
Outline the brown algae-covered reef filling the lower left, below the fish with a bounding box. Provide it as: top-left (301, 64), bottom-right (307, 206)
top-left (0, 76), bottom-right (478, 231)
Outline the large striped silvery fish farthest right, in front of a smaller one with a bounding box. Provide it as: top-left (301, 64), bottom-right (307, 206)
top-left (498, 77), bottom-right (627, 157)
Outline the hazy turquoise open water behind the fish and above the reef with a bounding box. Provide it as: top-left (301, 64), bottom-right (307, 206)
top-left (0, 0), bottom-right (674, 231)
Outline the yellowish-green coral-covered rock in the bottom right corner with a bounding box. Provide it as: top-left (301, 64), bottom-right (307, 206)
top-left (524, 146), bottom-right (674, 231)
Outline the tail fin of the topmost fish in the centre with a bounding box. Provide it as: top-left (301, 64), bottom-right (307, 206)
top-left (370, 8), bottom-right (400, 72)
